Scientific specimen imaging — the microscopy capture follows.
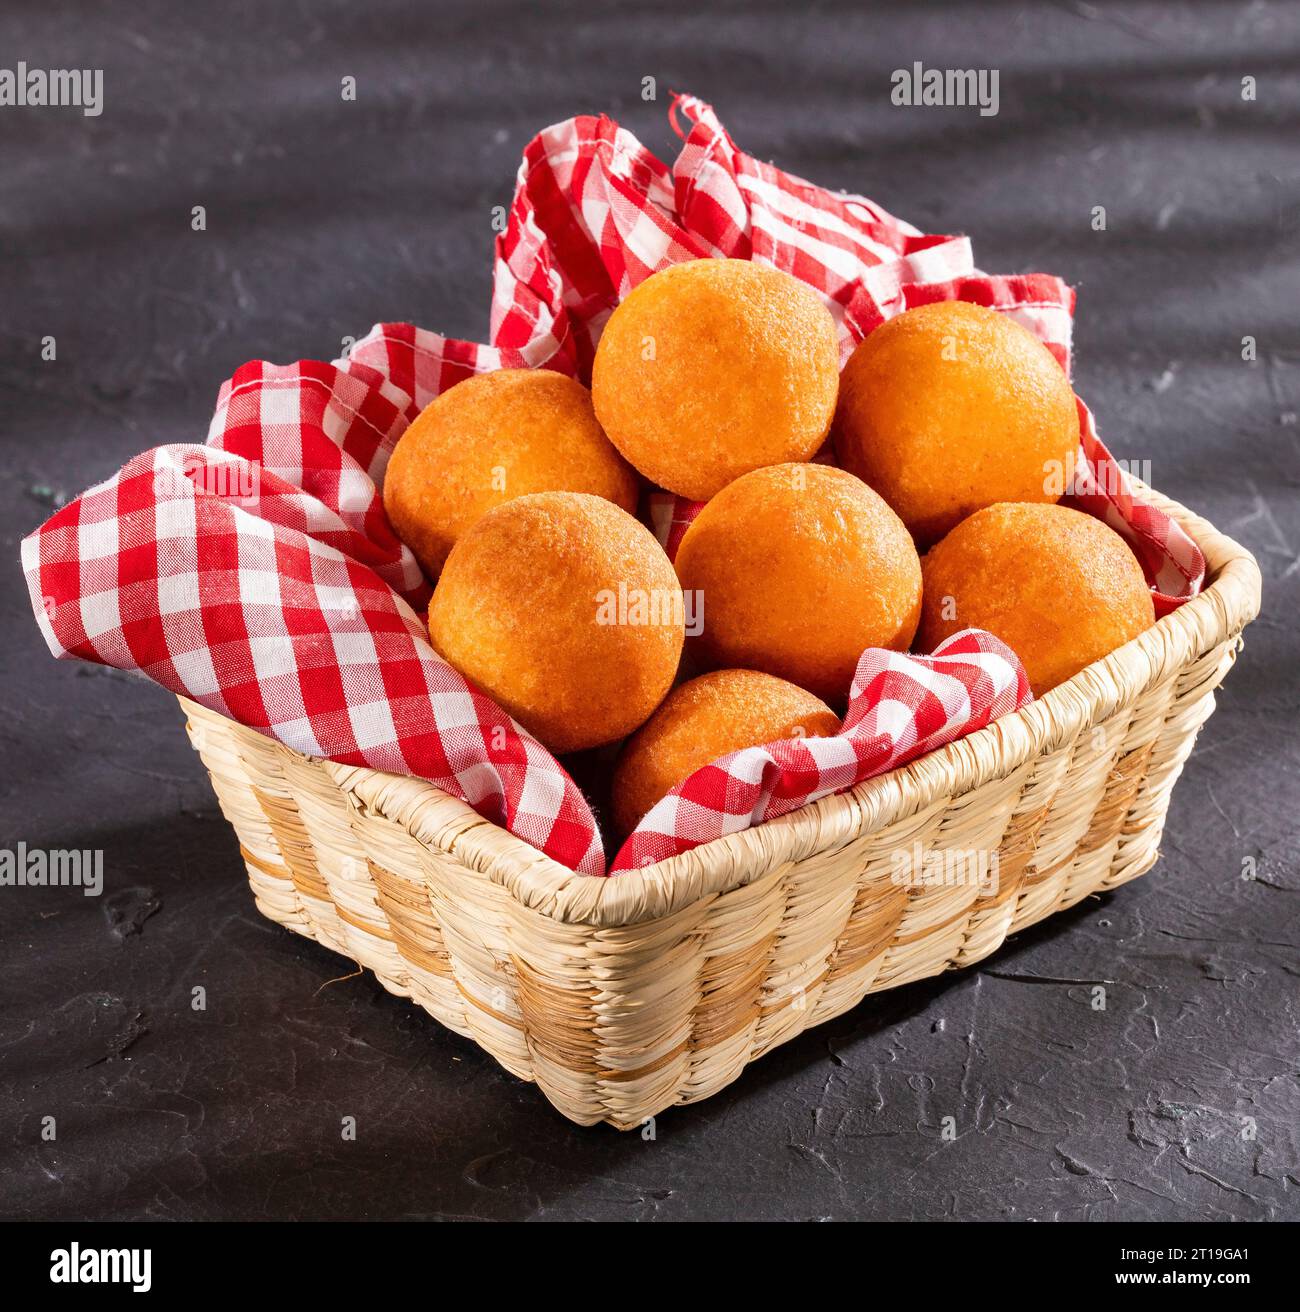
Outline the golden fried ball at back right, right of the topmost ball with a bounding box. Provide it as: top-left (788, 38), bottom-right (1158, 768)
top-left (834, 300), bottom-right (1078, 550)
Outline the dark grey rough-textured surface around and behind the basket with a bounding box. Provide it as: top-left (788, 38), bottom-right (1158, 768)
top-left (0, 0), bottom-right (1300, 1220)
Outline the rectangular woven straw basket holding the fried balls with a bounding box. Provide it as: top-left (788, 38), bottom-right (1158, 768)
top-left (181, 492), bottom-right (1259, 1128)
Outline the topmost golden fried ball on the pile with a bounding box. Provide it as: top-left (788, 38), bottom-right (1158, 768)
top-left (592, 260), bottom-right (840, 501)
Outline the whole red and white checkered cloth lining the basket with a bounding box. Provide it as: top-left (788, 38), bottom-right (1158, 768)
top-left (22, 97), bottom-right (1204, 874)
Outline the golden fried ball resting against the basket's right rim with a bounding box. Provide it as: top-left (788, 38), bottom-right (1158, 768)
top-left (917, 504), bottom-right (1156, 697)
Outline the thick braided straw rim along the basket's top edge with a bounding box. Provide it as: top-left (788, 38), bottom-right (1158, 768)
top-left (187, 479), bottom-right (1261, 929)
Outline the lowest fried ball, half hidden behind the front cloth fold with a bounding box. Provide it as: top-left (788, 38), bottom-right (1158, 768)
top-left (610, 669), bottom-right (840, 837)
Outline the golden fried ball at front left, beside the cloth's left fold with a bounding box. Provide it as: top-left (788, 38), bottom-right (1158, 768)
top-left (429, 492), bottom-right (685, 752)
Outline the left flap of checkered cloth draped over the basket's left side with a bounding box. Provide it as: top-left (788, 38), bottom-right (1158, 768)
top-left (22, 362), bottom-right (605, 874)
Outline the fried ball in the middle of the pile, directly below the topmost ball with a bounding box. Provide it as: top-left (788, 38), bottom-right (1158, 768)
top-left (677, 464), bottom-right (921, 706)
